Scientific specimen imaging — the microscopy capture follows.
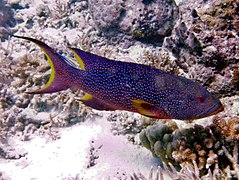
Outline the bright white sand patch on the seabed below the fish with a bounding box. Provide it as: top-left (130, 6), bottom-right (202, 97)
top-left (0, 118), bottom-right (164, 180)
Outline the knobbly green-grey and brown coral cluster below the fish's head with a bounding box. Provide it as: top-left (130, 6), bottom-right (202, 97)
top-left (140, 116), bottom-right (239, 178)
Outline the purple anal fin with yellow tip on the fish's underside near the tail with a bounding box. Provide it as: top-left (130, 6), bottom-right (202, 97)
top-left (77, 94), bottom-right (115, 111)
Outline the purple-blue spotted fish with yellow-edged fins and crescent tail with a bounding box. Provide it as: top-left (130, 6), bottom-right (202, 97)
top-left (14, 35), bottom-right (223, 121)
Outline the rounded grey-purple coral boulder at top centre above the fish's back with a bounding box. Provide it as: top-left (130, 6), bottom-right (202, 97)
top-left (89, 0), bottom-right (178, 43)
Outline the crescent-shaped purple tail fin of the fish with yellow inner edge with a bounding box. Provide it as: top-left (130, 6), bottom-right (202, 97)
top-left (13, 35), bottom-right (73, 94)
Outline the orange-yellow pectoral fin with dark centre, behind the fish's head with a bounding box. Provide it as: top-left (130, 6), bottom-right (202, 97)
top-left (132, 99), bottom-right (170, 119)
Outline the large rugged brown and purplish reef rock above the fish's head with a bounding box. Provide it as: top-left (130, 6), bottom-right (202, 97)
top-left (163, 0), bottom-right (239, 96)
